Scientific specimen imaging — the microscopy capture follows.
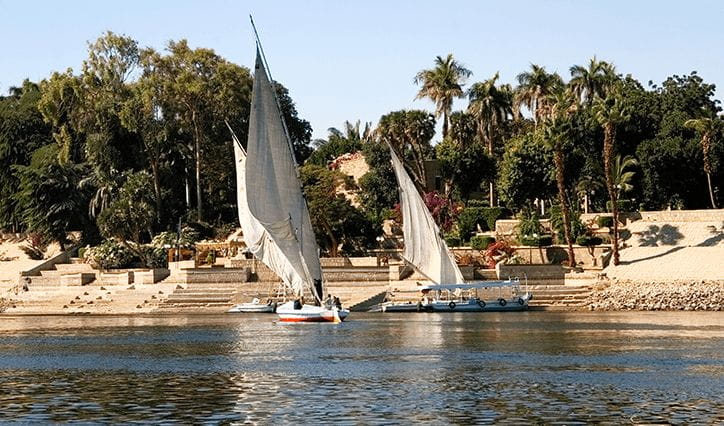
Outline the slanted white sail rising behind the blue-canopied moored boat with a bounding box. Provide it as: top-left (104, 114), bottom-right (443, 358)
top-left (390, 148), bottom-right (465, 284)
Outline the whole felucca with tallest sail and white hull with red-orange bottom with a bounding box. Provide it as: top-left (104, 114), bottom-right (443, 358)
top-left (237, 26), bottom-right (349, 322)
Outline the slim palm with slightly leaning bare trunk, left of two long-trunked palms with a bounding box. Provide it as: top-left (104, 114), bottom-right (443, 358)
top-left (544, 91), bottom-right (576, 268)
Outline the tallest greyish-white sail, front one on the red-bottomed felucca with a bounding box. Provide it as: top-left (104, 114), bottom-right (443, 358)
top-left (244, 51), bottom-right (322, 299)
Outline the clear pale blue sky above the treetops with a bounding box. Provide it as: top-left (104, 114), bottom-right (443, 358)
top-left (0, 0), bottom-right (724, 139)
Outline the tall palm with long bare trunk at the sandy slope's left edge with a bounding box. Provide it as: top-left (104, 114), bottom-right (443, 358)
top-left (593, 87), bottom-right (629, 265)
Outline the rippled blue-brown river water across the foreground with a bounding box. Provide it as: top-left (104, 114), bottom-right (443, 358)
top-left (0, 312), bottom-right (724, 424)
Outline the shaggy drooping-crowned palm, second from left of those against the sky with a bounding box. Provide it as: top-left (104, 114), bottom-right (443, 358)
top-left (468, 72), bottom-right (513, 207)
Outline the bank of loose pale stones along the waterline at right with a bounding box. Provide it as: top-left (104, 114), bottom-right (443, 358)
top-left (587, 280), bottom-right (724, 311)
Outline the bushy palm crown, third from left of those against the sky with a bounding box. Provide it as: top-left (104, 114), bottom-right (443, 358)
top-left (515, 64), bottom-right (563, 125)
